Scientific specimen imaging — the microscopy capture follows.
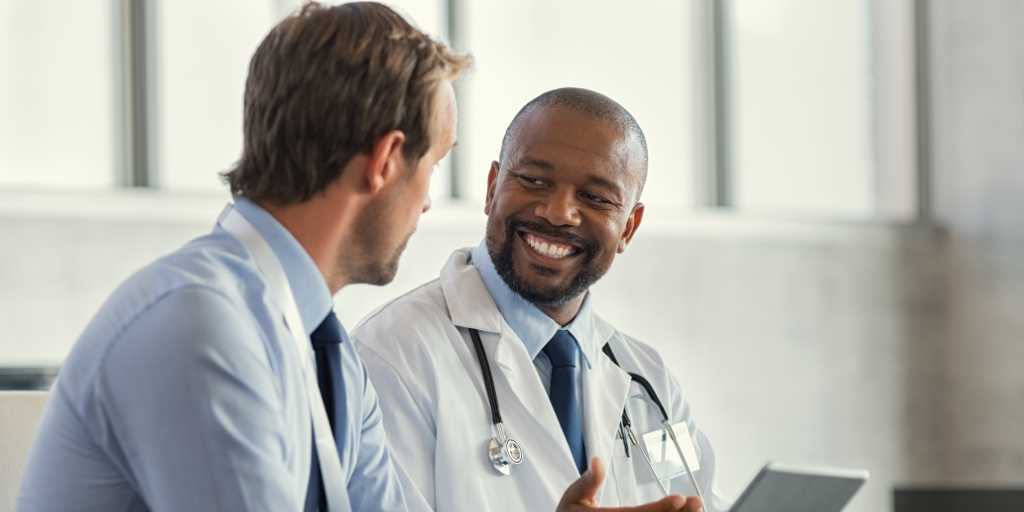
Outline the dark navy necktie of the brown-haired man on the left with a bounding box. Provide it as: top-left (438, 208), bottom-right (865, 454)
top-left (305, 311), bottom-right (346, 511)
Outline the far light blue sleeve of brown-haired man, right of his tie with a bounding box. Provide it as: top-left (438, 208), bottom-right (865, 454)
top-left (345, 343), bottom-right (407, 511)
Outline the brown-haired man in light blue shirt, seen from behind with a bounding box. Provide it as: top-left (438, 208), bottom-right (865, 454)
top-left (17, 3), bottom-right (468, 512)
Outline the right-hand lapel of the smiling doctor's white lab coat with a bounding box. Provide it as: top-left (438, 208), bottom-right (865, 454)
top-left (583, 317), bottom-right (631, 503)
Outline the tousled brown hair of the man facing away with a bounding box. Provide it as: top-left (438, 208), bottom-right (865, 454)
top-left (224, 2), bottom-right (469, 205)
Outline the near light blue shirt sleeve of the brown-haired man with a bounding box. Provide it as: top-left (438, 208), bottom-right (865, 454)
top-left (85, 287), bottom-right (308, 512)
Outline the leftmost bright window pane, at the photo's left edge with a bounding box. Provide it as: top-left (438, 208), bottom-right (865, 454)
top-left (0, 0), bottom-right (117, 189)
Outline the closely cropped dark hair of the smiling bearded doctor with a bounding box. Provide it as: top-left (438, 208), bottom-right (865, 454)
top-left (499, 87), bottom-right (647, 201)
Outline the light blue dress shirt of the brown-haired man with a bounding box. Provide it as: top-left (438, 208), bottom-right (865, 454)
top-left (17, 199), bottom-right (406, 512)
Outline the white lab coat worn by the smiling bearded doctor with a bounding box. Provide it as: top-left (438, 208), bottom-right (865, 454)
top-left (351, 249), bottom-right (728, 512)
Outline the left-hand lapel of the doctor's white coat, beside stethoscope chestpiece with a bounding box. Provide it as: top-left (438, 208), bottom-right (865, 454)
top-left (440, 249), bottom-right (585, 481)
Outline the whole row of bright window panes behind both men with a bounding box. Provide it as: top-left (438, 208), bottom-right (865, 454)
top-left (0, 0), bottom-right (915, 222)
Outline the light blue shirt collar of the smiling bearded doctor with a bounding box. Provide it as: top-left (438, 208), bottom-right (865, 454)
top-left (470, 241), bottom-right (606, 368)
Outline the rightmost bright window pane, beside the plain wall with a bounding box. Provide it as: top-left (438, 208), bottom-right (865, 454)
top-left (726, 0), bottom-right (874, 217)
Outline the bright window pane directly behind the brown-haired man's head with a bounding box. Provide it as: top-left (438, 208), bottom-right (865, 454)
top-left (156, 0), bottom-right (446, 195)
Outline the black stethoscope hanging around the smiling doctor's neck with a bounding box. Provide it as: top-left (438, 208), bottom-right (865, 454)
top-left (469, 329), bottom-right (703, 500)
